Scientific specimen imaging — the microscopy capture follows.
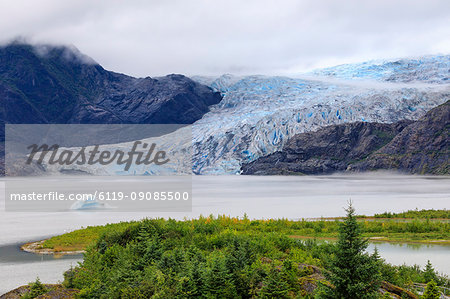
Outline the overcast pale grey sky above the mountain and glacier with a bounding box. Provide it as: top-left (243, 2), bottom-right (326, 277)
top-left (0, 0), bottom-right (450, 76)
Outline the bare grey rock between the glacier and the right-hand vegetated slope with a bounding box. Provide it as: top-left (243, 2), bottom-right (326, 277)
top-left (242, 121), bottom-right (409, 175)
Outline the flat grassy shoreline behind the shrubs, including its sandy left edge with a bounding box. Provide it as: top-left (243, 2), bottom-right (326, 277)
top-left (16, 210), bottom-right (450, 255)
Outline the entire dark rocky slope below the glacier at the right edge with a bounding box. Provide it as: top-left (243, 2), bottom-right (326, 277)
top-left (242, 101), bottom-right (450, 175)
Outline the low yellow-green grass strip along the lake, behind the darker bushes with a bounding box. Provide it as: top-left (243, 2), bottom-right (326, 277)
top-left (42, 210), bottom-right (450, 252)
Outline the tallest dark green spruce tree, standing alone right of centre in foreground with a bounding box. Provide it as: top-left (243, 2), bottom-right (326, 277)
top-left (319, 202), bottom-right (381, 299)
